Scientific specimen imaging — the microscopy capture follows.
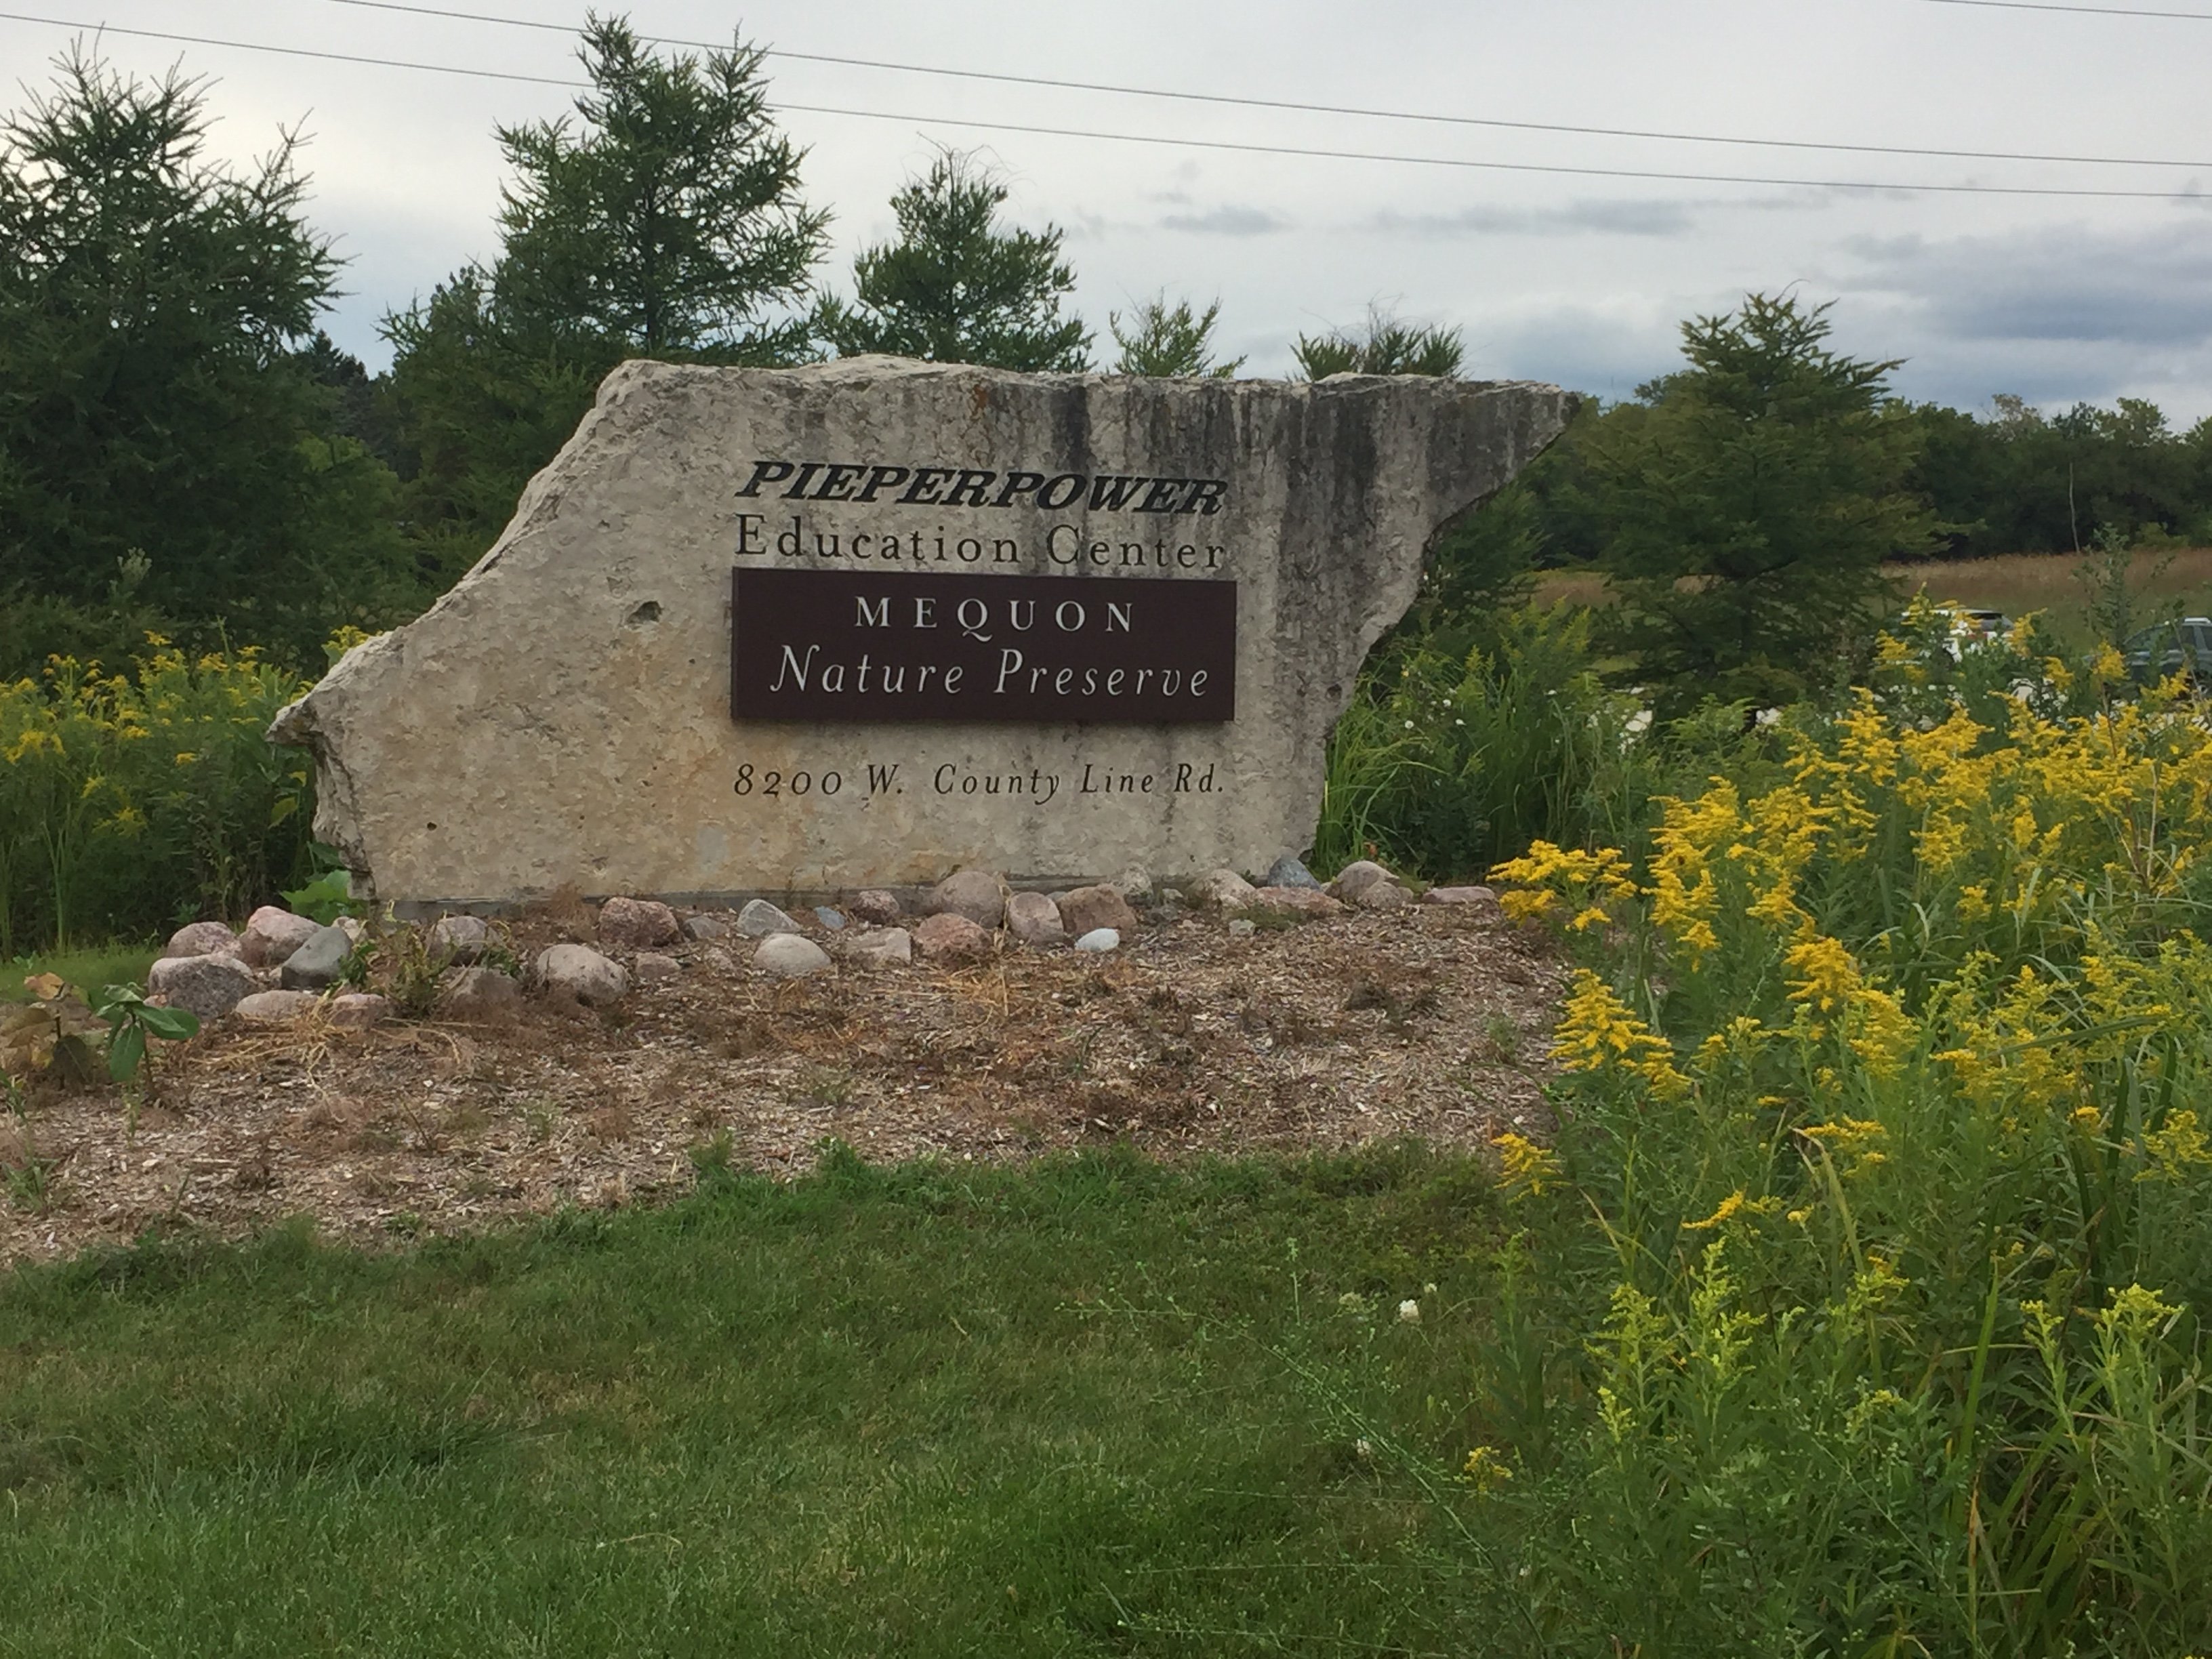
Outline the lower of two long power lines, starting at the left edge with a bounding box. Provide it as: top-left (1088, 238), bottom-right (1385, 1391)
top-left (0, 11), bottom-right (2212, 201)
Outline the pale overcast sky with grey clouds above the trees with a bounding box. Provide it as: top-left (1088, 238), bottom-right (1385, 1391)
top-left (13, 0), bottom-right (2212, 425)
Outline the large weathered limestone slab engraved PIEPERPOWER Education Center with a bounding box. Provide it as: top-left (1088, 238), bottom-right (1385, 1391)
top-left (272, 356), bottom-right (1573, 905)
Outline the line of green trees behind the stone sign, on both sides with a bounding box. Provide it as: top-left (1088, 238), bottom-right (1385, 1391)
top-left (0, 18), bottom-right (2212, 716)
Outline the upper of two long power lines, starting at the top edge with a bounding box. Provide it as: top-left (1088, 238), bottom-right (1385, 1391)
top-left (312, 0), bottom-right (2212, 168)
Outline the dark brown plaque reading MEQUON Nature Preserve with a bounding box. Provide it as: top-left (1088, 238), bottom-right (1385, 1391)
top-left (730, 569), bottom-right (1237, 723)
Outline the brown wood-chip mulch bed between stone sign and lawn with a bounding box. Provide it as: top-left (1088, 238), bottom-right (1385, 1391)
top-left (0, 907), bottom-right (1561, 1261)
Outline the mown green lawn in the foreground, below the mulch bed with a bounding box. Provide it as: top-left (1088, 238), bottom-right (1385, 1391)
top-left (0, 1150), bottom-right (1500, 1657)
